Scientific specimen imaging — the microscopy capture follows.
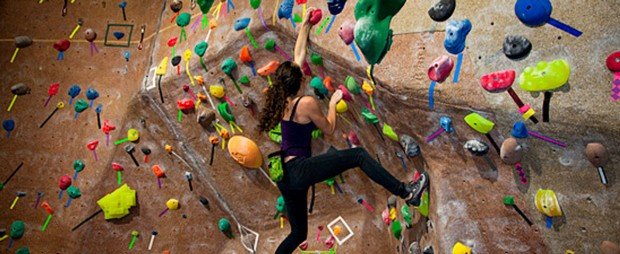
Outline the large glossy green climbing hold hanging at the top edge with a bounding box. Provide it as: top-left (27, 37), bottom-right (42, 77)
top-left (354, 0), bottom-right (406, 65)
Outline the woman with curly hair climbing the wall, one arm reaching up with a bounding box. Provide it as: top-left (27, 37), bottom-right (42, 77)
top-left (258, 8), bottom-right (428, 254)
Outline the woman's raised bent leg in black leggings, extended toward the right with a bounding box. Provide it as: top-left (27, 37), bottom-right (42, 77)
top-left (292, 147), bottom-right (409, 198)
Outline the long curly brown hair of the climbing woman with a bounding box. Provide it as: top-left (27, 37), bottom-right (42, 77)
top-left (258, 61), bottom-right (303, 132)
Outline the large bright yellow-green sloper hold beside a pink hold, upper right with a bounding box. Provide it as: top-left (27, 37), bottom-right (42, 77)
top-left (519, 59), bottom-right (570, 92)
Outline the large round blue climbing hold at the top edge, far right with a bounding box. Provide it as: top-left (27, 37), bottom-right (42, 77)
top-left (515, 0), bottom-right (553, 27)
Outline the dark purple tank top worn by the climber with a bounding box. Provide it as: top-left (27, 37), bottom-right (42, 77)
top-left (281, 96), bottom-right (316, 158)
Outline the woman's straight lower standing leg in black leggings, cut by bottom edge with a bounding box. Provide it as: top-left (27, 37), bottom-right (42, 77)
top-left (276, 188), bottom-right (308, 254)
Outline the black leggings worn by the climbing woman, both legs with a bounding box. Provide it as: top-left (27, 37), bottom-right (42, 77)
top-left (276, 147), bottom-right (408, 254)
